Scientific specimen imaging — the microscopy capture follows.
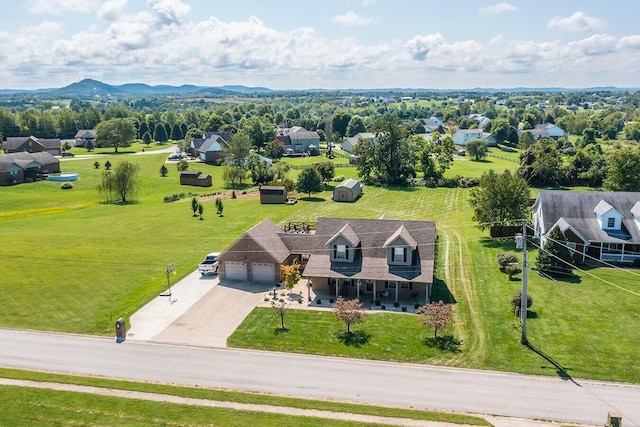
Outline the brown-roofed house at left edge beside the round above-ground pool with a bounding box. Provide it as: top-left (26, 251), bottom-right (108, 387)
top-left (0, 152), bottom-right (60, 185)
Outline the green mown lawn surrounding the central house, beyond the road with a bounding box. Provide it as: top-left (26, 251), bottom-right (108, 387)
top-left (0, 154), bottom-right (640, 383)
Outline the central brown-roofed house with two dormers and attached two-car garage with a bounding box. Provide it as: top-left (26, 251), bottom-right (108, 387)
top-left (218, 217), bottom-right (436, 303)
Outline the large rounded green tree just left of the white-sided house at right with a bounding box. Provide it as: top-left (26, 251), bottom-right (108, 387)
top-left (469, 169), bottom-right (529, 230)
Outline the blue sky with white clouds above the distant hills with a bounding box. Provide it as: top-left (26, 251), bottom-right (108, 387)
top-left (0, 0), bottom-right (640, 89)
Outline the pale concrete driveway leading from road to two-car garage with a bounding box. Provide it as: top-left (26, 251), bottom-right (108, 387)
top-left (127, 270), bottom-right (270, 347)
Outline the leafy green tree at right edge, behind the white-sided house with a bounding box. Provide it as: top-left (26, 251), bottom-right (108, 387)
top-left (604, 147), bottom-right (640, 191)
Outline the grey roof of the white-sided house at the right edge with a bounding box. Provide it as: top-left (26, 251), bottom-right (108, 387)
top-left (534, 190), bottom-right (640, 243)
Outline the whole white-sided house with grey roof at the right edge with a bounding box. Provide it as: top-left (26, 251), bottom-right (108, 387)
top-left (532, 190), bottom-right (640, 263)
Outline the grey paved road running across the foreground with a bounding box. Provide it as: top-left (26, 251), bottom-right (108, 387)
top-left (0, 329), bottom-right (640, 427)
